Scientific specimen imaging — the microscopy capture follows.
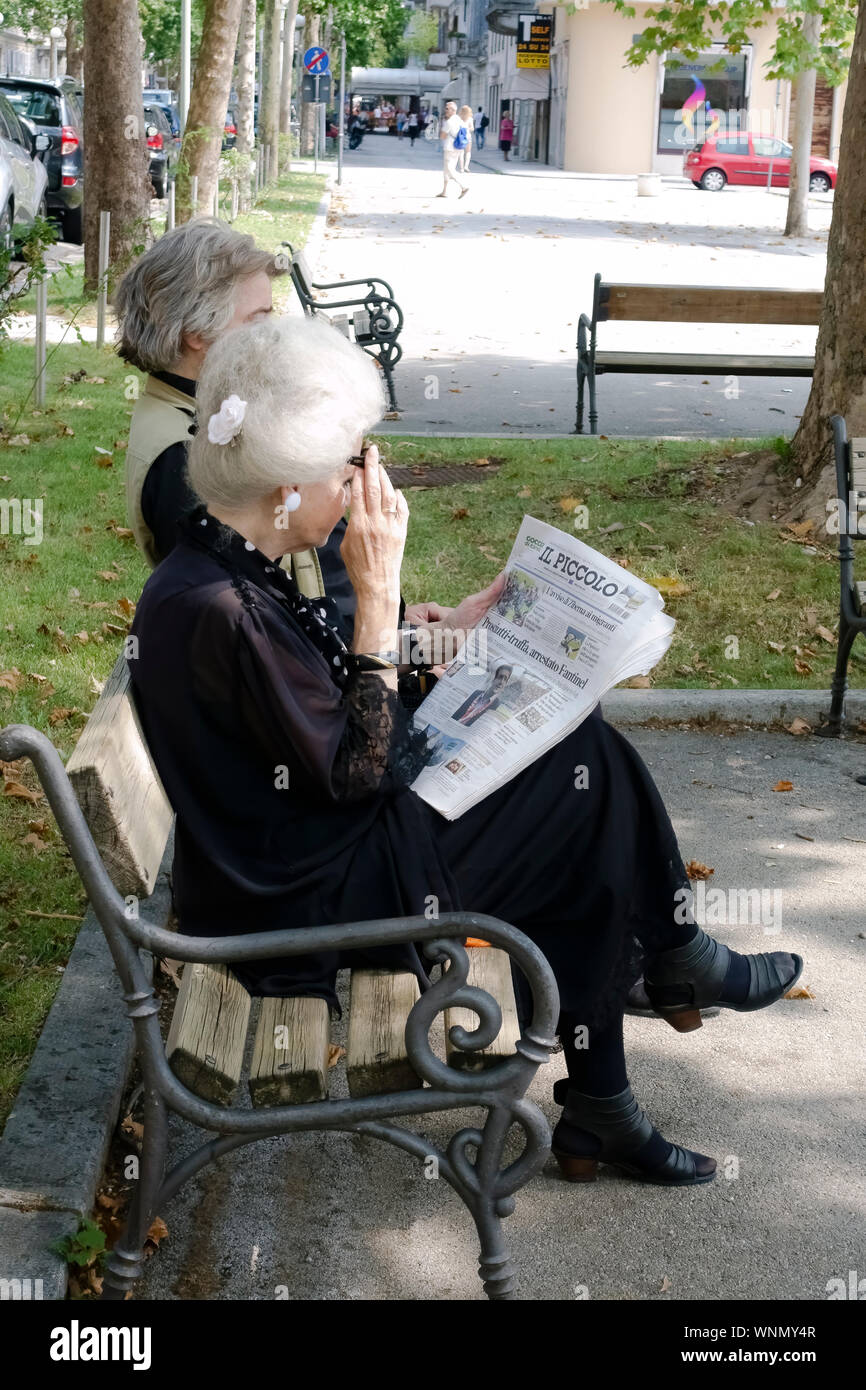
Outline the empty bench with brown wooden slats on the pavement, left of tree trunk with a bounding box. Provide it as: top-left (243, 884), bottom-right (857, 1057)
top-left (574, 275), bottom-right (823, 434)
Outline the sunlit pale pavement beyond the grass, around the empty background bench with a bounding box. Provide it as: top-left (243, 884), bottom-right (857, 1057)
top-left (317, 136), bottom-right (831, 438)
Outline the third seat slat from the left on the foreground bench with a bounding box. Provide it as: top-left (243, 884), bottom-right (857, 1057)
top-left (346, 970), bottom-right (421, 1097)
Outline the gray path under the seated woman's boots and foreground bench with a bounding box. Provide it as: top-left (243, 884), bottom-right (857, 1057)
top-left (140, 730), bottom-right (866, 1301)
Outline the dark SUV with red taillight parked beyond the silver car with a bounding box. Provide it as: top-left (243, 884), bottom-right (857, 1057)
top-left (0, 78), bottom-right (85, 246)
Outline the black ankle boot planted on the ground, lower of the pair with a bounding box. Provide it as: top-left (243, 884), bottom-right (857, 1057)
top-left (552, 1080), bottom-right (716, 1187)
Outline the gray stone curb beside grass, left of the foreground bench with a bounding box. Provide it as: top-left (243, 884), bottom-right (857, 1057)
top-left (0, 855), bottom-right (171, 1298)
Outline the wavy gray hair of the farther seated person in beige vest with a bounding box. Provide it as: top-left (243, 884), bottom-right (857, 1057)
top-left (114, 217), bottom-right (285, 371)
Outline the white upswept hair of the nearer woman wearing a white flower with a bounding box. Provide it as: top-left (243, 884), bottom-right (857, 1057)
top-left (188, 318), bottom-right (385, 510)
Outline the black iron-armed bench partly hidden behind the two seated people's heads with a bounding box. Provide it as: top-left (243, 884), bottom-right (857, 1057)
top-left (282, 242), bottom-right (403, 410)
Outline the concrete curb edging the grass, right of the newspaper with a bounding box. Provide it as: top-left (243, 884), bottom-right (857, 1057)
top-left (602, 688), bottom-right (866, 728)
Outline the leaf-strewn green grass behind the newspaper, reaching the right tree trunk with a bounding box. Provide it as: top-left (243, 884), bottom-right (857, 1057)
top-left (381, 438), bottom-right (863, 689)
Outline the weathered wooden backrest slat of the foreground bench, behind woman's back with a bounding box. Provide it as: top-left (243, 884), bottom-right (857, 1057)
top-left (67, 655), bottom-right (172, 898)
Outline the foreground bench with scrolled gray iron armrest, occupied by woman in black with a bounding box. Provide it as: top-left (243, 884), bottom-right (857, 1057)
top-left (0, 657), bottom-right (559, 1298)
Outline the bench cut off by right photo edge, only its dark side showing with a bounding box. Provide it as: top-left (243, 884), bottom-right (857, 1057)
top-left (816, 416), bottom-right (866, 739)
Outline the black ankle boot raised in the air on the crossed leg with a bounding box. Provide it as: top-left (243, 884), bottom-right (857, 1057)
top-left (645, 930), bottom-right (803, 1033)
